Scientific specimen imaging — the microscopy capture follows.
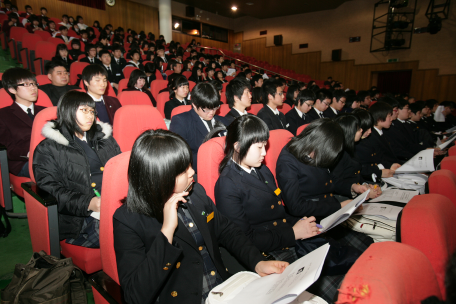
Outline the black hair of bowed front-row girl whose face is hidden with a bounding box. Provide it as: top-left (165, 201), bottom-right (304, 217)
top-left (287, 118), bottom-right (344, 168)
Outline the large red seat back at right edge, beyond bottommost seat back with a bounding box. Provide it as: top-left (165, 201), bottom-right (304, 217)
top-left (401, 194), bottom-right (456, 298)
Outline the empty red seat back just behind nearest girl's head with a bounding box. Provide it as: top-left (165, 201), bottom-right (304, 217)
top-left (113, 105), bottom-right (167, 152)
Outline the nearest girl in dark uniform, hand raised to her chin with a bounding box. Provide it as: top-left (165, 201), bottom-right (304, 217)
top-left (113, 130), bottom-right (288, 304)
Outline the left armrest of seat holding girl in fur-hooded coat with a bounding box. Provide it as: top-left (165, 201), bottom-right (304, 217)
top-left (21, 182), bottom-right (60, 257)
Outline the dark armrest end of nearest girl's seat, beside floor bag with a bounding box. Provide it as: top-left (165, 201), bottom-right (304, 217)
top-left (89, 271), bottom-right (127, 304)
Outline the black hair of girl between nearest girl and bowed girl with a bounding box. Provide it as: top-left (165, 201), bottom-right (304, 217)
top-left (219, 114), bottom-right (269, 173)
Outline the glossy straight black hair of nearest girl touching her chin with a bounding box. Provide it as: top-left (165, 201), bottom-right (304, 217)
top-left (125, 129), bottom-right (192, 222)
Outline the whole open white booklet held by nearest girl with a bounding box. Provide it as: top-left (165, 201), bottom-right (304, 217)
top-left (206, 244), bottom-right (329, 304)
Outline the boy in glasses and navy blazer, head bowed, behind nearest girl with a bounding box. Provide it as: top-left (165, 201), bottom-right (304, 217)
top-left (169, 82), bottom-right (228, 172)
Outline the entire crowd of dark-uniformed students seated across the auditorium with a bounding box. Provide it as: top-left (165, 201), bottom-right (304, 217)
top-left (0, 7), bottom-right (456, 303)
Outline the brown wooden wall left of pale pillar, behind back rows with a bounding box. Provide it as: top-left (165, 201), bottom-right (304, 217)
top-left (16, 0), bottom-right (159, 37)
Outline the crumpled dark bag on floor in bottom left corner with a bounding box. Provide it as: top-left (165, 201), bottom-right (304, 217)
top-left (1, 251), bottom-right (87, 304)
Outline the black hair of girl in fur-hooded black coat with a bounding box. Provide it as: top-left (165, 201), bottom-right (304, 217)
top-left (54, 91), bottom-right (97, 141)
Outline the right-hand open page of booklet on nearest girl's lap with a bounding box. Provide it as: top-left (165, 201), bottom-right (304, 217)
top-left (218, 244), bottom-right (329, 304)
